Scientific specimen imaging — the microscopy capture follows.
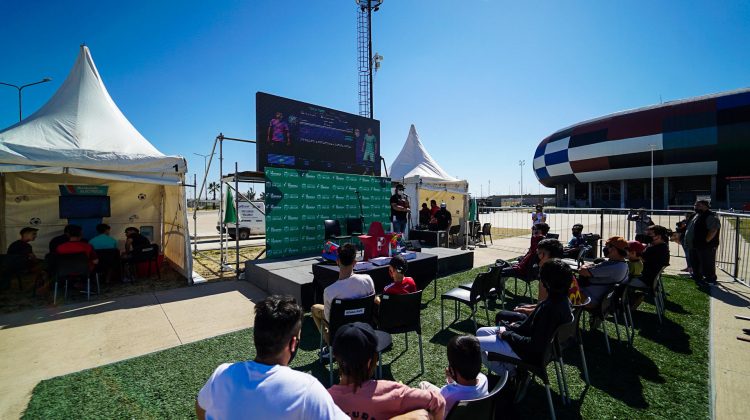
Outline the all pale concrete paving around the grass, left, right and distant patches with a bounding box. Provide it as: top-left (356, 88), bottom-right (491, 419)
top-left (0, 237), bottom-right (750, 419)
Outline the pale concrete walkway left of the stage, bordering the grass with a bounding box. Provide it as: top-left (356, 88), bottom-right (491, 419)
top-left (0, 281), bottom-right (265, 419)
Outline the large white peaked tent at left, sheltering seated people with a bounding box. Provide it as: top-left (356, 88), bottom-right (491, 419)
top-left (0, 46), bottom-right (192, 279)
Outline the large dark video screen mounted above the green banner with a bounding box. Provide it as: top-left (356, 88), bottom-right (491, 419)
top-left (255, 92), bottom-right (380, 176)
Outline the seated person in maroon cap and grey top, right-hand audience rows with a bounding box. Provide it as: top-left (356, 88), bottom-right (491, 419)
top-left (578, 236), bottom-right (628, 307)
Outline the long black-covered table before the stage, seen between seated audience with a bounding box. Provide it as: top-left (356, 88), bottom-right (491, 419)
top-left (313, 252), bottom-right (437, 303)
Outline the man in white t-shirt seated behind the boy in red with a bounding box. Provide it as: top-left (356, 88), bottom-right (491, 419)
top-left (310, 244), bottom-right (375, 343)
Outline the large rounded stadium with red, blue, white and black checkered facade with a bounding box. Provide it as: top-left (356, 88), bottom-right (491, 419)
top-left (534, 88), bottom-right (750, 209)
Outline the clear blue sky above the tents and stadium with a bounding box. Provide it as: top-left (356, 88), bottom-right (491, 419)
top-left (0, 0), bottom-right (750, 194)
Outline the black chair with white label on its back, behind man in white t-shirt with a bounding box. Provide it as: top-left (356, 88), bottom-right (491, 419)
top-left (320, 295), bottom-right (392, 385)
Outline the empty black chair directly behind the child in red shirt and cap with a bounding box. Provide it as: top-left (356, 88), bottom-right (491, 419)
top-left (378, 290), bottom-right (424, 373)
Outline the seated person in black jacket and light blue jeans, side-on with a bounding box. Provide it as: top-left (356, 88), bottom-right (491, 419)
top-left (477, 259), bottom-right (573, 371)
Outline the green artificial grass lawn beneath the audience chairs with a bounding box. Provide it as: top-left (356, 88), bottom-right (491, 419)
top-left (24, 270), bottom-right (709, 419)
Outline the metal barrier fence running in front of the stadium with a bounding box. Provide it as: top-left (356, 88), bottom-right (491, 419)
top-left (479, 207), bottom-right (750, 285)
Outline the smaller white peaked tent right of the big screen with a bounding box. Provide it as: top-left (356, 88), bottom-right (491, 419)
top-left (390, 124), bottom-right (469, 230)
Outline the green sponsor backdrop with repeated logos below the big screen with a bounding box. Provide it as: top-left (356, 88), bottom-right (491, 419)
top-left (265, 168), bottom-right (391, 258)
